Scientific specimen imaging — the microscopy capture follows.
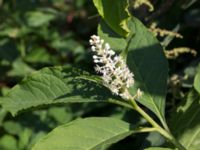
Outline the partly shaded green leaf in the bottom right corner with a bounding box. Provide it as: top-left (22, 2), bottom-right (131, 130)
top-left (170, 91), bottom-right (200, 150)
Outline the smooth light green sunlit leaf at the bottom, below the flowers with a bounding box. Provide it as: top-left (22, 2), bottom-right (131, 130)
top-left (33, 117), bottom-right (133, 150)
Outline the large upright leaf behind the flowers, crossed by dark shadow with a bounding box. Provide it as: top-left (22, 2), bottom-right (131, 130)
top-left (98, 18), bottom-right (168, 124)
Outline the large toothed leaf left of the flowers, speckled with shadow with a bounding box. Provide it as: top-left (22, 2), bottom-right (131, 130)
top-left (2, 67), bottom-right (117, 115)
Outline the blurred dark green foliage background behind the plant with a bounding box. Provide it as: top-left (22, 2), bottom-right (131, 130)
top-left (0, 0), bottom-right (200, 150)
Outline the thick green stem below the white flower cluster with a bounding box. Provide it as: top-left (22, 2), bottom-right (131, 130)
top-left (131, 99), bottom-right (186, 150)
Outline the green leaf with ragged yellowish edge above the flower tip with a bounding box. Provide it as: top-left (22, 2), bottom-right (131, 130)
top-left (93, 0), bottom-right (130, 37)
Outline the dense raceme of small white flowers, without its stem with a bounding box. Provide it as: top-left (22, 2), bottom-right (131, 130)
top-left (89, 35), bottom-right (142, 100)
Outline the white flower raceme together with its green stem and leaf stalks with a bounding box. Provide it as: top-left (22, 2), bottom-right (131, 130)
top-left (89, 35), bottom-right (186, 150)
